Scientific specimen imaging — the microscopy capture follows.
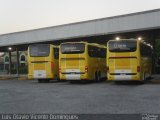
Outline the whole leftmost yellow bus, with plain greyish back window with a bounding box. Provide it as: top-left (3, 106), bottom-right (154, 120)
top-left (28, 44), bottom-right (59, 82)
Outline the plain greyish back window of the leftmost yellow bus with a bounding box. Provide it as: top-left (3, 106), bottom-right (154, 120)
top-left (29, 44), bottom-right (50, 57)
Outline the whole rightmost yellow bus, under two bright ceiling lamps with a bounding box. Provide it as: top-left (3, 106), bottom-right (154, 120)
top-left (107, 39), bottom-right (152, 81)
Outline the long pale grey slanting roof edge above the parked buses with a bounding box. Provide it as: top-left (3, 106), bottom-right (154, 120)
top-left (0, 9), bottom-right (160, 46)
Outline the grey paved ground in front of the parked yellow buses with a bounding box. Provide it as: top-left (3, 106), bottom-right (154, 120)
top-left (0, 76), bottom-right (160, 114)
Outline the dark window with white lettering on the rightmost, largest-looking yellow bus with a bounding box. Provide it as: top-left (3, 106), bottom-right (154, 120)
top-left (109, 40), bottom-right (137, 52)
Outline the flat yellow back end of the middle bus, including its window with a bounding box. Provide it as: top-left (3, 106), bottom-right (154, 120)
top-left (59, 43), bottom-right (87, 80)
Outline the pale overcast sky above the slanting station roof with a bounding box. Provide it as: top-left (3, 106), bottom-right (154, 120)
top-left (0, 0), bottom-right (160, 34)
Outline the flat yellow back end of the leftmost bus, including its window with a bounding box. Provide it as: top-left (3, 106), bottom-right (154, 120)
top-left (28, 44), bottom-right (54, 79)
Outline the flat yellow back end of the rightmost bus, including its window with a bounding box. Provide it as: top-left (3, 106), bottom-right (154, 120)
top-left (107, 40), bottom-right (139, 81)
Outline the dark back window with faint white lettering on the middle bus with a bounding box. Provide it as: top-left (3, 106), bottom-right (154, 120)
top-left (61, 43), bottom-right (85, 54)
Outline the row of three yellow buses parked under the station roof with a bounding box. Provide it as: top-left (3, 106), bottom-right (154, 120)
top-left (28, 39), bottom-right (152, 82)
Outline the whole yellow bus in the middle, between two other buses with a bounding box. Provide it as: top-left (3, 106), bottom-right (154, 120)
top-left (59, 42), bottom-right (107, 81)
